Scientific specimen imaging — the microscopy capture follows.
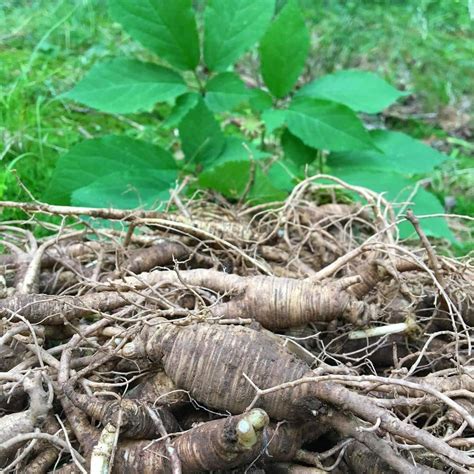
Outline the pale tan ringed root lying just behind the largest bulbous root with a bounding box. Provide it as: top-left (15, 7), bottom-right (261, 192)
top-left (104, 270), bottom-right (374, 330)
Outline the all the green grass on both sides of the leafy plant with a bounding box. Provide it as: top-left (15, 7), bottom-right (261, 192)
top-left (0, 0), bottom-right (474, 246)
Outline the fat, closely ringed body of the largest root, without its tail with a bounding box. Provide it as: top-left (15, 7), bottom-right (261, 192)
top-left (123, 322), bottom-right (309, 420)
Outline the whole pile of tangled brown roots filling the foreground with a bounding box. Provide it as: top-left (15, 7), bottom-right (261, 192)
top-left (0, 177), bottom-right (474, 474)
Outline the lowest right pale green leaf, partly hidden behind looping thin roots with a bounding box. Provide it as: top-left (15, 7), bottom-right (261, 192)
top-left (331, 166), bottom-right (454, 241)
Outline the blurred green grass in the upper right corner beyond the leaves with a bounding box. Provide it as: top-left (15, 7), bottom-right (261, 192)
top-left (302, 0), bottom-right (474, 110)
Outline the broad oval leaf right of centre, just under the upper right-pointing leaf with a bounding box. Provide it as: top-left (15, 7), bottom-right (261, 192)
top-left (286, 97), bottom-right (375, 151)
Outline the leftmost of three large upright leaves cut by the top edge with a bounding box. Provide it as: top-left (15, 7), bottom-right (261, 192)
top-left (109, 0), bottom-right (199, 70)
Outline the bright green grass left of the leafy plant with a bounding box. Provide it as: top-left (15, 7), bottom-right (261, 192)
top-left (0, 0), bottom-right (178, 213)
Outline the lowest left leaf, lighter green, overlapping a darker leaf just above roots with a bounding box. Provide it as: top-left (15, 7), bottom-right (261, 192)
top-left (71, 170), bottom-right (172, 209)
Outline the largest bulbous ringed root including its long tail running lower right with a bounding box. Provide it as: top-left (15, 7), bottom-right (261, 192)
top-left (123, 321), bottom-right (474, 466)
